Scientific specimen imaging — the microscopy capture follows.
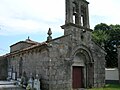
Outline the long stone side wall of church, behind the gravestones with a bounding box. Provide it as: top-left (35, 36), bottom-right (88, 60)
top-left (10, 47), bottom-right (50, 90)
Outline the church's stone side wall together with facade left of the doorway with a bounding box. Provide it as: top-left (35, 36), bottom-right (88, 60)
top-left (9, 37), bottom-right (72, 90)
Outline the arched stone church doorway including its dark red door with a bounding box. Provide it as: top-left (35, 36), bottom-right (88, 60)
top-left (72, 48), bottom-right (94, 89)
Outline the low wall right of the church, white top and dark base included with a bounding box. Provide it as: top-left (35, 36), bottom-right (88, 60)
top-left (105, 68), bottom-right (119, 84)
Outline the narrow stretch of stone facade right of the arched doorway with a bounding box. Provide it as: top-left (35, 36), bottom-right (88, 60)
top-left (91, 42), bottom-right (106, 87)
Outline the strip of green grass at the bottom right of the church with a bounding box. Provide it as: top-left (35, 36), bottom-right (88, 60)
top-left (89, 84), bottom-right (120, 90)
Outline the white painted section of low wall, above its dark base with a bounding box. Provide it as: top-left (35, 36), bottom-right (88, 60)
top-left (105, 68), bottom-right (119, 80)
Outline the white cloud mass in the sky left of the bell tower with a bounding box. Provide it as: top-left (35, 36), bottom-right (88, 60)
top-left (0, 0), bottom-right (64, 35)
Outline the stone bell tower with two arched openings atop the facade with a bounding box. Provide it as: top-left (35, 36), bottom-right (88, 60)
top-left (61, 0), bottom-right (90, 35)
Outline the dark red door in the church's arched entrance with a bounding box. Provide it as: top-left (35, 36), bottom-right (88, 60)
top-left (72, 66), bottom-right (83, 89)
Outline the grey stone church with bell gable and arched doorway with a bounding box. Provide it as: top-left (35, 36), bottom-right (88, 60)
top-left (0, 0), bottom-right (105, 90)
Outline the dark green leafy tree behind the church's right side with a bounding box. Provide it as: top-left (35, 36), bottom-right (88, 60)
top-left (92, 23), bottom-right (120, 68)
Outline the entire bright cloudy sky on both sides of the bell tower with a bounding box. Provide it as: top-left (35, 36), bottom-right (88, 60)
top-left (0, 0), bottom-right (120, 55)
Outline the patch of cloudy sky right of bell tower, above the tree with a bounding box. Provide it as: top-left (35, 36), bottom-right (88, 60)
top-left (88, 0), bottom-right (120, 28)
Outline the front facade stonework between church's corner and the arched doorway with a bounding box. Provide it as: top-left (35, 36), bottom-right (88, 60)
top-left (50, 36), bottom-right (72, 90)
